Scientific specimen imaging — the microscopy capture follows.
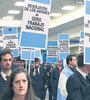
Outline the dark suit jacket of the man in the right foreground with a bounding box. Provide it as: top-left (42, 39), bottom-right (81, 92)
top-left (66, 71), bottom-right (88, 100)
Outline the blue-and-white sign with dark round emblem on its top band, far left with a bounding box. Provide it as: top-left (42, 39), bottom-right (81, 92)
top-left (3, 27), bottom-right (18, 56)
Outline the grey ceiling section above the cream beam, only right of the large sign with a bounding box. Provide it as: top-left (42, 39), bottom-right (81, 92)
top-left (51, 0), bottom-right (84, 14)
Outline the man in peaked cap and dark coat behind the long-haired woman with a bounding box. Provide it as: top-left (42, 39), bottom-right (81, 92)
top-left (30, 58), bottom-right (47, 100)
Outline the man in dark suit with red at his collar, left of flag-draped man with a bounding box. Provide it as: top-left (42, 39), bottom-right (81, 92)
top-left (51, 59), bottom-right (63, 100)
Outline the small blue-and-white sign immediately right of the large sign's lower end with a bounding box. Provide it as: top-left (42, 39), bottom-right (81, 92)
top-left (47, 41), bottom-right (58, 63)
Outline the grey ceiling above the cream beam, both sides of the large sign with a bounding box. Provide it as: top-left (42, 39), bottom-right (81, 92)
top-left (0, 0), bottom-right (84, 20)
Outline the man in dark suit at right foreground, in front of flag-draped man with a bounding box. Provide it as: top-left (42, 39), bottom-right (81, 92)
top-left (66, 53), bottom-right (90, 100)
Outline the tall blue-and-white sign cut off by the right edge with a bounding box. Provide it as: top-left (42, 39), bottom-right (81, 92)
top-left (84, 0), bottom-right (90, 64)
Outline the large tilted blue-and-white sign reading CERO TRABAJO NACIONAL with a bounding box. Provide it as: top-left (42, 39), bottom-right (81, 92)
top-left (20, 0), bottom-right (50, 48)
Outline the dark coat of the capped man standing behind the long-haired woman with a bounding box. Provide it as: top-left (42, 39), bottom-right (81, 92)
top-left (30, 67), bottom-right (47, 100)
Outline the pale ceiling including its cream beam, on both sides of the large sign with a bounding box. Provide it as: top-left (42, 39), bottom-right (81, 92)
top-left (0, 0), bottom-right (84, 47)
